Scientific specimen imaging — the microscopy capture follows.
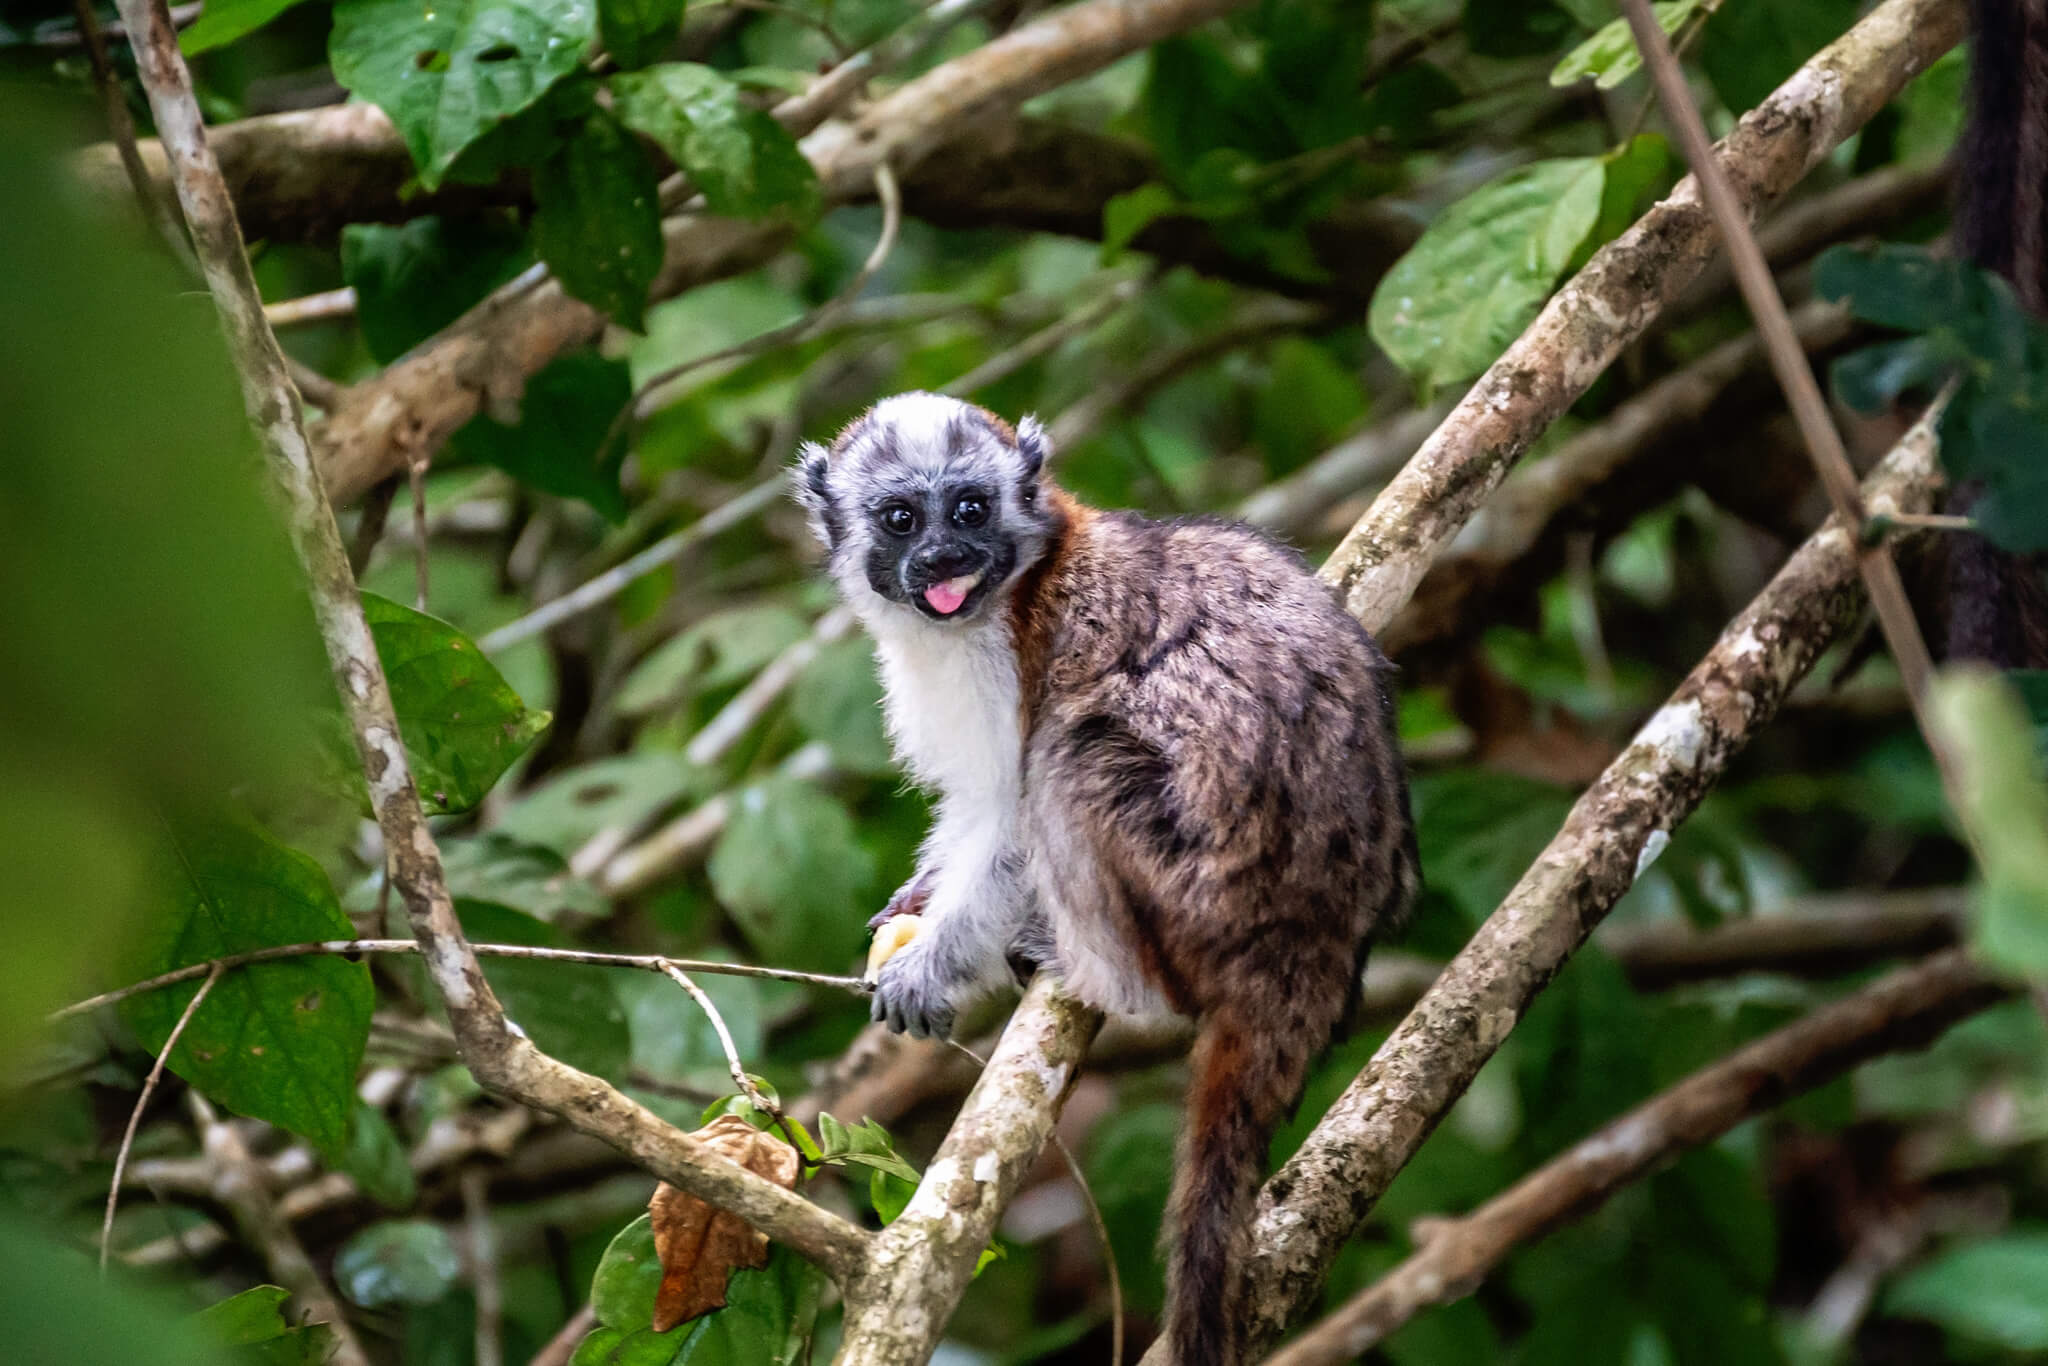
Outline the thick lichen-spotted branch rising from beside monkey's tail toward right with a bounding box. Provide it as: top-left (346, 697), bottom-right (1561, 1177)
top-left (1171, 416), bottom-right (1937, 1366)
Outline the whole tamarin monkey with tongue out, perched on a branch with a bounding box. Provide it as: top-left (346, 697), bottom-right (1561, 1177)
top-left (797, 393), bottom-right (1421, 1366)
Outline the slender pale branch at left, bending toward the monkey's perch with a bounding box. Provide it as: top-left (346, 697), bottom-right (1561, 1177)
top-left (121, 0), bottom-right (866, 1280)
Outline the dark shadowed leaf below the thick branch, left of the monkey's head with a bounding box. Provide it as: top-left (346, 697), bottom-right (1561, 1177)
top-left (449, 350), bottom-right (633, 522)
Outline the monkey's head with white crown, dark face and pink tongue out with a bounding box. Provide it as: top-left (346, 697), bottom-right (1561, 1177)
top-left (797, 393), bottom-right (1057, 623)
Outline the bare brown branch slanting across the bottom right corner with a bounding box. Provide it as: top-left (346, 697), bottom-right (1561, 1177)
top-left (1268, 948), bottom-right (2007, 1366)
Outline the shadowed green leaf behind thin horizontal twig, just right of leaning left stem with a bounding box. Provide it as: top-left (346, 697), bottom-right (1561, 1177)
top-left (455, 901), bottom-right (630, 1079)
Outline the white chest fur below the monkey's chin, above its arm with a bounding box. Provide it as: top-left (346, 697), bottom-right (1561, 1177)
top-left (870, 612), bottom-right (1024, 811)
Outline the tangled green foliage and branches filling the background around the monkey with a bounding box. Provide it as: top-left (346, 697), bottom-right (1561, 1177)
top-left (0, 0), bottom-right (2048, 1366)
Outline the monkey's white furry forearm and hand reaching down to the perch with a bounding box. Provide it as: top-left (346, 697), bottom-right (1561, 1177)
top-left (872, 801), bottom-right (1030, 1038)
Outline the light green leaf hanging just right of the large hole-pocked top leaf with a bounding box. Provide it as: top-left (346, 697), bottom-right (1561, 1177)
top-left (610, 61), bottom-right (819, 219)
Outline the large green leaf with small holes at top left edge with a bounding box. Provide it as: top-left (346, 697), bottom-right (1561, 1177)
top-left (328, 0), bottom-right (596, 190)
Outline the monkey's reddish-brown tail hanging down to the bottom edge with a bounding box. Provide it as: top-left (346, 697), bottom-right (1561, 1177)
top-left (1165, 1006), bottom-right (1317, 1366)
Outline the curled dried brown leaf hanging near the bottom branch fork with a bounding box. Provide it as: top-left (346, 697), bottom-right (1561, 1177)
top-left (647, 1114), bottom-right (797, 1333)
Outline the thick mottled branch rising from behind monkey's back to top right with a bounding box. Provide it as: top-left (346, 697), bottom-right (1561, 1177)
top-left (1323, 0), bottom-right (1964, 631)
